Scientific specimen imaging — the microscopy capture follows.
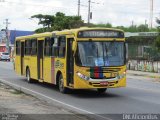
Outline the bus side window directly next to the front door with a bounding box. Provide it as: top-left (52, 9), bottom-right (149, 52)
top-left (58, 36), bottom-right (66, 57)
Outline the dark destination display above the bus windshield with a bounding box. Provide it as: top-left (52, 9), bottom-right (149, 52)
top-left (78, 30), bottom-right (124, 38)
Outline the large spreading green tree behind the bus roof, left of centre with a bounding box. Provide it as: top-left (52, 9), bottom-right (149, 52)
top-left (31, 12), bottom-right (84, 33)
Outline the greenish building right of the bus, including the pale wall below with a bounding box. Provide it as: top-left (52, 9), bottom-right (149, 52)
top-left (125, 32), bottom-right (160, 73)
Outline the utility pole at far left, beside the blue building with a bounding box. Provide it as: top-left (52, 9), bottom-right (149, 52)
top-left (4, 19), bottom-right (10, 53)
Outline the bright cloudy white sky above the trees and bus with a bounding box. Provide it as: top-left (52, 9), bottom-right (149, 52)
top-left (0, 0), bottom-right (160, 31)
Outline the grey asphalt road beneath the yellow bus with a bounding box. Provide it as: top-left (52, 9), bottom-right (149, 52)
top-left (0, 62), bottom-right (160, 117)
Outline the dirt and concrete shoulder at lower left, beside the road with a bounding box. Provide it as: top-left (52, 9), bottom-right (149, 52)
top-left (0, 82), bottom-right (92, 120)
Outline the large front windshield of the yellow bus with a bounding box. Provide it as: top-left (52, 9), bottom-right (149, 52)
top-left (76, 41), bottom-right (125, 67)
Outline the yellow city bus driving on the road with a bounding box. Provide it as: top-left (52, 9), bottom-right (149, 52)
top-left (15, 28), bottom-right (126, 93)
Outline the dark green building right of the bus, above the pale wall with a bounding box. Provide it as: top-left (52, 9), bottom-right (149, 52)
top-left (125, 32), bottom-right (159, 60)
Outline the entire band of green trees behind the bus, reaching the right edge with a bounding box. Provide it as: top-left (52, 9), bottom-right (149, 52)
top-left (31, 12), bottom-right (160, 33)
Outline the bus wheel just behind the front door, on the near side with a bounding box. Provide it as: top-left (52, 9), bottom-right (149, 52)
top-left (58, 74), bottom-right (68, 93)
